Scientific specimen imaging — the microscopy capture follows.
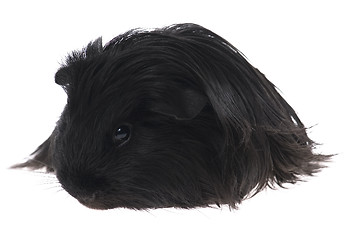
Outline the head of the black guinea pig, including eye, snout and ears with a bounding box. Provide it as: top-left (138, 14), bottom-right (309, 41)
top-left (48, 40), bottom-right (222, 209)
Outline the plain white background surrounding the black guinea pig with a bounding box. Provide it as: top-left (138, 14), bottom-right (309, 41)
top-left (0, 0), bottom-right (361, 239)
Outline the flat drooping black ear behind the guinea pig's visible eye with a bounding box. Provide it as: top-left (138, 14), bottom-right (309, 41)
top-left (151, 89), bottom-right (208, 120)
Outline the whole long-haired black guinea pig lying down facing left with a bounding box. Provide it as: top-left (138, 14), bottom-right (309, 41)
top-left (14, 24), bottom-right (330, 209)
